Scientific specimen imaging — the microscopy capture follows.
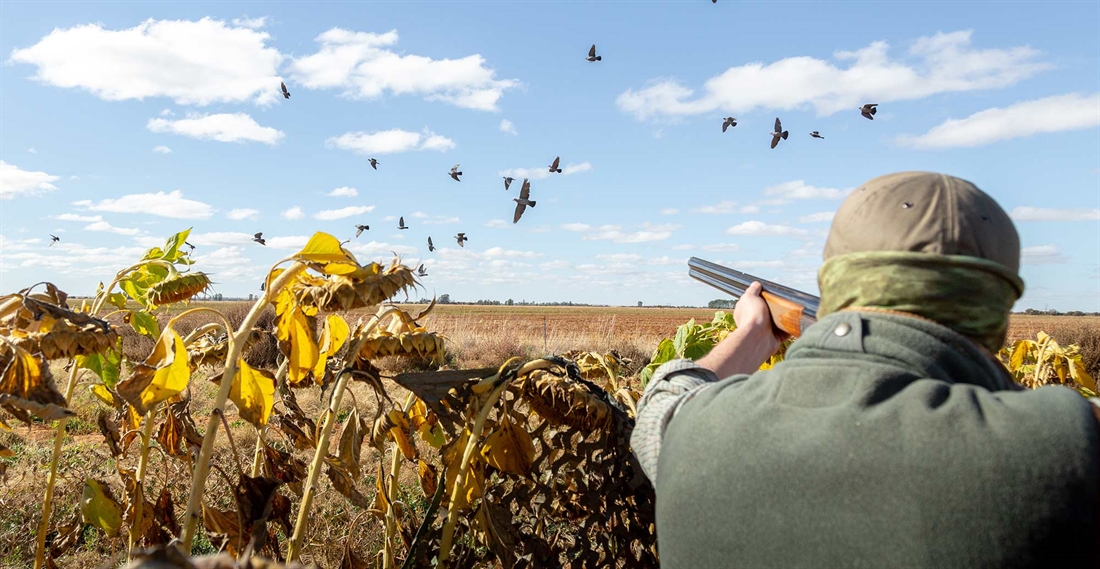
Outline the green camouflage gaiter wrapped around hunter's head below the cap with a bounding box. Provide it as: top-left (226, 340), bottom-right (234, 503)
top-left (817, 251), bottom-right (1024, 353)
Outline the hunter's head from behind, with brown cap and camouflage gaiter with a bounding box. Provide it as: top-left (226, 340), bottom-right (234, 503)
top-left (818, 172), bottom-right (1023, 351)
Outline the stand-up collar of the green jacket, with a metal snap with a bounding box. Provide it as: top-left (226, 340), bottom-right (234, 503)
top-left (787, 310), bottom-right (1023, 391)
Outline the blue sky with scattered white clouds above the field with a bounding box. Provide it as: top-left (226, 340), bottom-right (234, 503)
top-left (0, 0), bottom-right (1100, 310)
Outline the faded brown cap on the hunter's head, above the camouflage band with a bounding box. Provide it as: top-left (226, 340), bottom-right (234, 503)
top-left (825, 172), bottom-right (1020, 273)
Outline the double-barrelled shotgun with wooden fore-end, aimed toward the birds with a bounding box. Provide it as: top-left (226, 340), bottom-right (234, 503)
top-left (688, 256), bottom-right (821, 338)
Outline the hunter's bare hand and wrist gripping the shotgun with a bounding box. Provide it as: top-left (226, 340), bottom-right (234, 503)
top-left (695, 283), bottom-right (789, 377)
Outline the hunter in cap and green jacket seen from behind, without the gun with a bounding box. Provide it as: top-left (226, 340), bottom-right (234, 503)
top-left (631, 172), bottom-right (1100, 569)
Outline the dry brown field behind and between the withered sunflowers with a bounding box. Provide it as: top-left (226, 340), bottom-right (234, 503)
top-left (0, 303), bottom-right (1100, 568)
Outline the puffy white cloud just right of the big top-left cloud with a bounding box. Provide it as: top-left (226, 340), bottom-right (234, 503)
top-left (289, 28), bottom-right (519, 111)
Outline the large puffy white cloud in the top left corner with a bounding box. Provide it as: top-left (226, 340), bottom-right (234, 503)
top-left (9, 18), bottom-right (283, 105)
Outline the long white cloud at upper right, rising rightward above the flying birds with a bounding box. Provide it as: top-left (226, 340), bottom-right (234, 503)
top-left (616, 30), bottom-right (1051, 120)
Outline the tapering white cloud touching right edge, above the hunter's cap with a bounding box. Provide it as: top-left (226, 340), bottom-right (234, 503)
top-left (898, 94), bottom-right (1100, 149)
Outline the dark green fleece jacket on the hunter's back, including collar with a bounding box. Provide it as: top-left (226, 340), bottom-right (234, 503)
top-left (635, 311), bottom-right (1100, 569)
